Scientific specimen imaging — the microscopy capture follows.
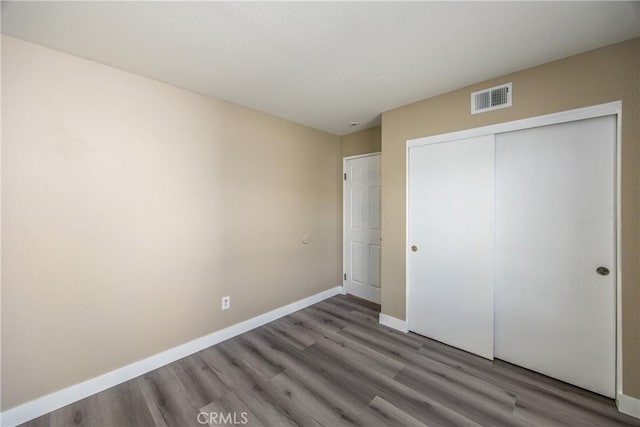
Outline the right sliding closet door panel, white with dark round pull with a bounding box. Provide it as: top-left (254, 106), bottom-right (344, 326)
top-left (495, 116), bottom-right (616, 397)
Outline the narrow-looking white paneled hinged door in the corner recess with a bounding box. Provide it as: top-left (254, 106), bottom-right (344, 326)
top-left (343, 154), bottom-right (382, 304)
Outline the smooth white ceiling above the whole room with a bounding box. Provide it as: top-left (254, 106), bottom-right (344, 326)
top-left (2, 1), bottom-right (640, 135)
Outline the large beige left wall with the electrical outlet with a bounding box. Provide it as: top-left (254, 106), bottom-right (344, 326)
top-left (1, 37), bottom-right (342, 410)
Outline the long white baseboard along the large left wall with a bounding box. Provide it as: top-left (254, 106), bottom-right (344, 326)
top-left (0, 286), bottom-right (343, 426)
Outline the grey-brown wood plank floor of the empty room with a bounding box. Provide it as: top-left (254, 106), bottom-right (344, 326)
top-left (26, 295), bottom-right (640, 427)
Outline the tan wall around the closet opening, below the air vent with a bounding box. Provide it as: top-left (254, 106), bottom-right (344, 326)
top-left (382, 39), bottom-right (640, 397)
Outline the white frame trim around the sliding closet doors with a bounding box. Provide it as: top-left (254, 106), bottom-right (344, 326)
top-left (405, 101), bottom-right (624, 406)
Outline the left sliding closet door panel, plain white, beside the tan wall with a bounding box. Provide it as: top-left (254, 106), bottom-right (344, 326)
top-left (407, 135), bottom-right (494, 359)
